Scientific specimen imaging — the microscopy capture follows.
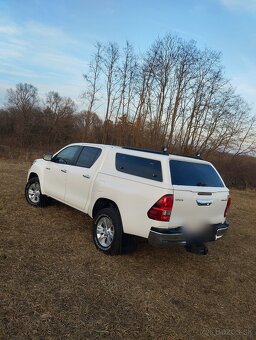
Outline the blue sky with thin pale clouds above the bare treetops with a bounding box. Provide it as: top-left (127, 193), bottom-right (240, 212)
top-left (0, 0), bottom-right (256, 113)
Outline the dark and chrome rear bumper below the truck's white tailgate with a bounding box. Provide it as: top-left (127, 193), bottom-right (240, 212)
top-left (148, 223), bottom-right (229, 245)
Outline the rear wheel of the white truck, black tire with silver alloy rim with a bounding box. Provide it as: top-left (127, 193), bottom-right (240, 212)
top-left (93, 208), bottom-right (123, 255)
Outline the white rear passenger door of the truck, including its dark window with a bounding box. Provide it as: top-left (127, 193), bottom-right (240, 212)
top-left (65, 146), bottom-right (102, 211)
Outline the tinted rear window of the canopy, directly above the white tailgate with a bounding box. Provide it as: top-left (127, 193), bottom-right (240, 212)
top-left (170, 160), bottom-right (224, 187)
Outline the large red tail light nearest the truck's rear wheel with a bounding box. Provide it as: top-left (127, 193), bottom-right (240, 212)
top-left (148, 195), bottom-right (173, 222)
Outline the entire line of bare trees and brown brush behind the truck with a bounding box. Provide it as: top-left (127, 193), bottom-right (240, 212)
top-left (0, 34), bottom-right (255, 187)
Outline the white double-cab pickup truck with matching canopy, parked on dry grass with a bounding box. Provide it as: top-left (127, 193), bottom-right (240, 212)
top-left (25, 143), bottom-right (230, 255)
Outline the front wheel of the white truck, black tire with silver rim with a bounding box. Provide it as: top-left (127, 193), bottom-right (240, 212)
top-left (25, 177), bottom-right (48, 207)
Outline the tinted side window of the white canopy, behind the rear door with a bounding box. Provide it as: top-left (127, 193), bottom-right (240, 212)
top-left (116, 153), bottom-right (163, 182)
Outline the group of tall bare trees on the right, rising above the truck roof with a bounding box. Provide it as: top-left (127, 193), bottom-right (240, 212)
top-left (84, 34), bottom-right (255, 154)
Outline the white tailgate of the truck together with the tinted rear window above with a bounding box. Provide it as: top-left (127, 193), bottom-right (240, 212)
top-left (170, 160), bottom-right (229, 232)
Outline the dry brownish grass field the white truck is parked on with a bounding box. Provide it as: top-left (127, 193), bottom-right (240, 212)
top-left (0, 160), bottom-right (256, 339)
